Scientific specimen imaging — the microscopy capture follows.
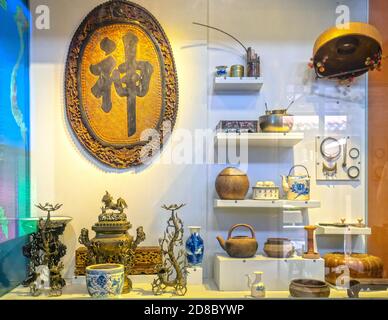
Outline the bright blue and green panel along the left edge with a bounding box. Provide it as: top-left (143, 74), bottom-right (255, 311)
top-left (0, 1), bottom-right (30, 294)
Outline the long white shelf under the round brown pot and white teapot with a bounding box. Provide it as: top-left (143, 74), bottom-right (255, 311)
top-left (214, 199), bottom-right (321, 210)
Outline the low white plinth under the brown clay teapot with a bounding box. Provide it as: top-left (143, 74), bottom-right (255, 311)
top-left (214, 254), bottom-right (325, 291)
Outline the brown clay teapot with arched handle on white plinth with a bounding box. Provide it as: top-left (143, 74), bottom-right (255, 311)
top-left (217, 224), bottom-right (259, 258)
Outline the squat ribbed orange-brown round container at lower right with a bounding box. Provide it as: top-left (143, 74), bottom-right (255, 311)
top-left (323, 252), bottom-right (384, 284)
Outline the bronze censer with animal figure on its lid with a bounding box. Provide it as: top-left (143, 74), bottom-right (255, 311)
top-left (79, 192), bottom-right (145, 293)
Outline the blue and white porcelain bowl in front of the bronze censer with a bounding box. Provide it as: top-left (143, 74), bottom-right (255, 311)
top-left (86, 264), bottom-right (124, 298)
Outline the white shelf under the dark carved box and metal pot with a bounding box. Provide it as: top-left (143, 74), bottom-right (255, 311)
top-left (216, 132), bottom-right (304, 148)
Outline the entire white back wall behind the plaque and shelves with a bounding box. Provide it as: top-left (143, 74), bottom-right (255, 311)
top-left (31, 0), bottom-right (367, 276)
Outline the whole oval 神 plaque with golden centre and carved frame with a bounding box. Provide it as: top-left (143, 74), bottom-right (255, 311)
top-left (65, 0), bottom-right (178, 169)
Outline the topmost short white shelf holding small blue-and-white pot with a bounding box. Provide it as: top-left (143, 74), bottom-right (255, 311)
top-left (214, 77), bottom-right (264, 91)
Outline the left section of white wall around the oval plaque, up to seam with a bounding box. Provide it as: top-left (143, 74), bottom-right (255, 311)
top-left (31, 0), bottom-right (207, 276)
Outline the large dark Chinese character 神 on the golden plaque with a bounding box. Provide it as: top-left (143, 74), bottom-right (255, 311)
top-left (90, 32), bottom-right (153, 137)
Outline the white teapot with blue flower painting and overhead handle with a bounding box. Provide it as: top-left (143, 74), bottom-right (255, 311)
top-left (281, 165), bottom-right (310, 201)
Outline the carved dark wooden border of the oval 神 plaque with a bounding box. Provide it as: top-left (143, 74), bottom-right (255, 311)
top-left (65, 0), bottom-right (179, 169)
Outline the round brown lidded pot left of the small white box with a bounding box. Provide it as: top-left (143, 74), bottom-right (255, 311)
top-left (216, 167), bottom-right (249, 200)
